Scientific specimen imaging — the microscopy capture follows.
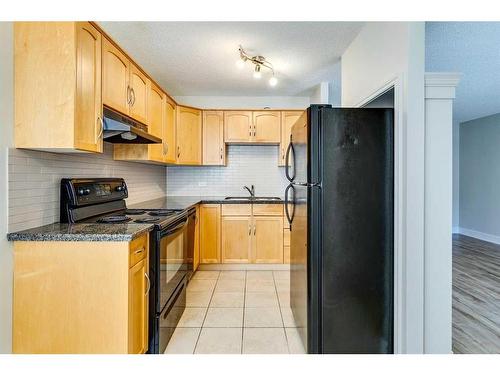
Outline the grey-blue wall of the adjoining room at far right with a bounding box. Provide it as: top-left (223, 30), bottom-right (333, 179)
top-left (459, 113), bottom-right (500, 243)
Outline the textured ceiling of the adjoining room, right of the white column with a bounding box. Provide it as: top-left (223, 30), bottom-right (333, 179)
top-left (425, 22), bottom-right (500, 122)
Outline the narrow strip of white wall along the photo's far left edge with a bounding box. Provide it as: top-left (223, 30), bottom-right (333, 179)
top-left (0, 22), bottom-right (14, 353)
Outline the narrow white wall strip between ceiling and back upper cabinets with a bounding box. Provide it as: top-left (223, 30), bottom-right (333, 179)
top-left (175, 96), bottom-right (310, 109)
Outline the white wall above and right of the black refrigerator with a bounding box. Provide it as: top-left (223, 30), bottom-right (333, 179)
top-left (341, 22), bottom-right (425, 353)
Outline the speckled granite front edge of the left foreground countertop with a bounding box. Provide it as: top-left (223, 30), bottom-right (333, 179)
top-left (7, 224), bottom-right (154, 242)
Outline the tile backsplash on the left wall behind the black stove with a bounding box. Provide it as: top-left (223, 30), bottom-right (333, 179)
top-left (9, 143), bottom-right (167, 232)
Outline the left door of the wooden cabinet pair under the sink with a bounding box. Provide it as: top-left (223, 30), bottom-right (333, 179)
top-left (222, 216), bottom-right (252, 263)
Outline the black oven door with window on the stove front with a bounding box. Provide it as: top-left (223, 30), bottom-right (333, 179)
top-left (157, 216), bottom-right (189, 311)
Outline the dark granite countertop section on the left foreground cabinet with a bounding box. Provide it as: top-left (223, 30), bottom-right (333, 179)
top-left (7, 223), bottom-right (153, 241)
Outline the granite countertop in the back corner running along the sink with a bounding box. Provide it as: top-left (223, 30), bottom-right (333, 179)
top-left (128, 195), bottom-right (283, 210)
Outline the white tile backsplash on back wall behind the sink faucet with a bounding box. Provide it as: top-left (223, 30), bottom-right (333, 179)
top-left (167, 145), bottom-right (287, 197)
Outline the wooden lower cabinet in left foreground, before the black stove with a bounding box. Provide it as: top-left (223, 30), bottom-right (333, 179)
top-left (12, 235), bottom-right (150, 354)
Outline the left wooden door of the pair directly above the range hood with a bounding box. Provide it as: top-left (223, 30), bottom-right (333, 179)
top-left (102, 38), bottom-right (129, 115)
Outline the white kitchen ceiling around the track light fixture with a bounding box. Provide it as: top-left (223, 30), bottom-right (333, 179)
top-left (99, 22), bottom-right (364, 96)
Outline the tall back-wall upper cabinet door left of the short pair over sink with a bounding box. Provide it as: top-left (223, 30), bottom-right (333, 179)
top-left (203, 111), bottom-right (226, 165)
